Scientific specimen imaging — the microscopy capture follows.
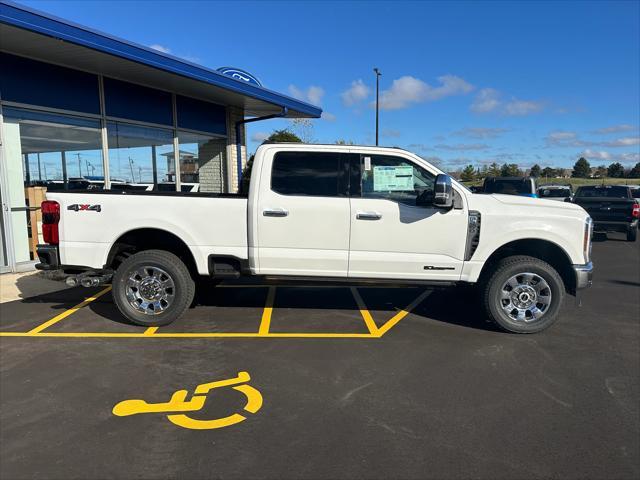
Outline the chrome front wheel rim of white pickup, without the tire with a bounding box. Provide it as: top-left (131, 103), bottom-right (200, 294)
top-left (500, 272), bottom-right (551, 322)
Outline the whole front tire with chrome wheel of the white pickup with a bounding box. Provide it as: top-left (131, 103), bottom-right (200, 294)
top-left (482, 255), bottom-right (565, 333)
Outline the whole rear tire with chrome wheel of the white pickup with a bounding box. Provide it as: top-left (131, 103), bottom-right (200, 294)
top-left (112, 250), bottom-right (195, 327)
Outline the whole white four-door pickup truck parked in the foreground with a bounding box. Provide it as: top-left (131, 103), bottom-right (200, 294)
top-left (37, 144), bottom-right (593, 333)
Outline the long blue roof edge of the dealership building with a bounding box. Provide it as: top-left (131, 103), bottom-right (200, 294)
top-left (0, 0), bottom-right (322, 118)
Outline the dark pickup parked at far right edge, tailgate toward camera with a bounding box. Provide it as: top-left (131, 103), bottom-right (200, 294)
top-left (572, 185), bottom-right (640, 242)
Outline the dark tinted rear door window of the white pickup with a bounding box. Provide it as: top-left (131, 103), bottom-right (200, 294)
top-left (271, 152), bottom-right (346, 197)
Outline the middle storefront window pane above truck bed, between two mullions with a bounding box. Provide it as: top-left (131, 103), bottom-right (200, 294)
top-left (107, 122), bottom-right (175, 190)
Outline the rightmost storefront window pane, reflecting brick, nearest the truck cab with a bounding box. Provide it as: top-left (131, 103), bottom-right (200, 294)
top-left (176, 131), bottom-right (227, 193)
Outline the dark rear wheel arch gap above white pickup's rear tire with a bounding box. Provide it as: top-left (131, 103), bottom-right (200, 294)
top-left (105, 228), bottom-right (198, 277)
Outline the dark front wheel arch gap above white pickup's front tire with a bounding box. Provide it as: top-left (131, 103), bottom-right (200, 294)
top-left (479, 238), bottom-right (576, 295)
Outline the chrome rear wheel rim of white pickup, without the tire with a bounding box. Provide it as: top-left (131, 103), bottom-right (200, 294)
top-left (125, 266), bottom-right (175, 315)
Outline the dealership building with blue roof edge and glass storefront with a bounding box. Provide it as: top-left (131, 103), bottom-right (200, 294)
top-left (0, 1), bottom-right (321, 272)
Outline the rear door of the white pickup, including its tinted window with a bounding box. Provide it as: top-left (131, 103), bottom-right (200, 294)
top-left (250, 150), bottom-right (350, 277)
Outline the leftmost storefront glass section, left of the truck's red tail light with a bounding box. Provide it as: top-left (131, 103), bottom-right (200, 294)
top-left (2, 107), bottom-right (104, 263)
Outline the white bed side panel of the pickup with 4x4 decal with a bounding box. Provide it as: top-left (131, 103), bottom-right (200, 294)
top-left (47, 190), bottom-right (248, 275)
